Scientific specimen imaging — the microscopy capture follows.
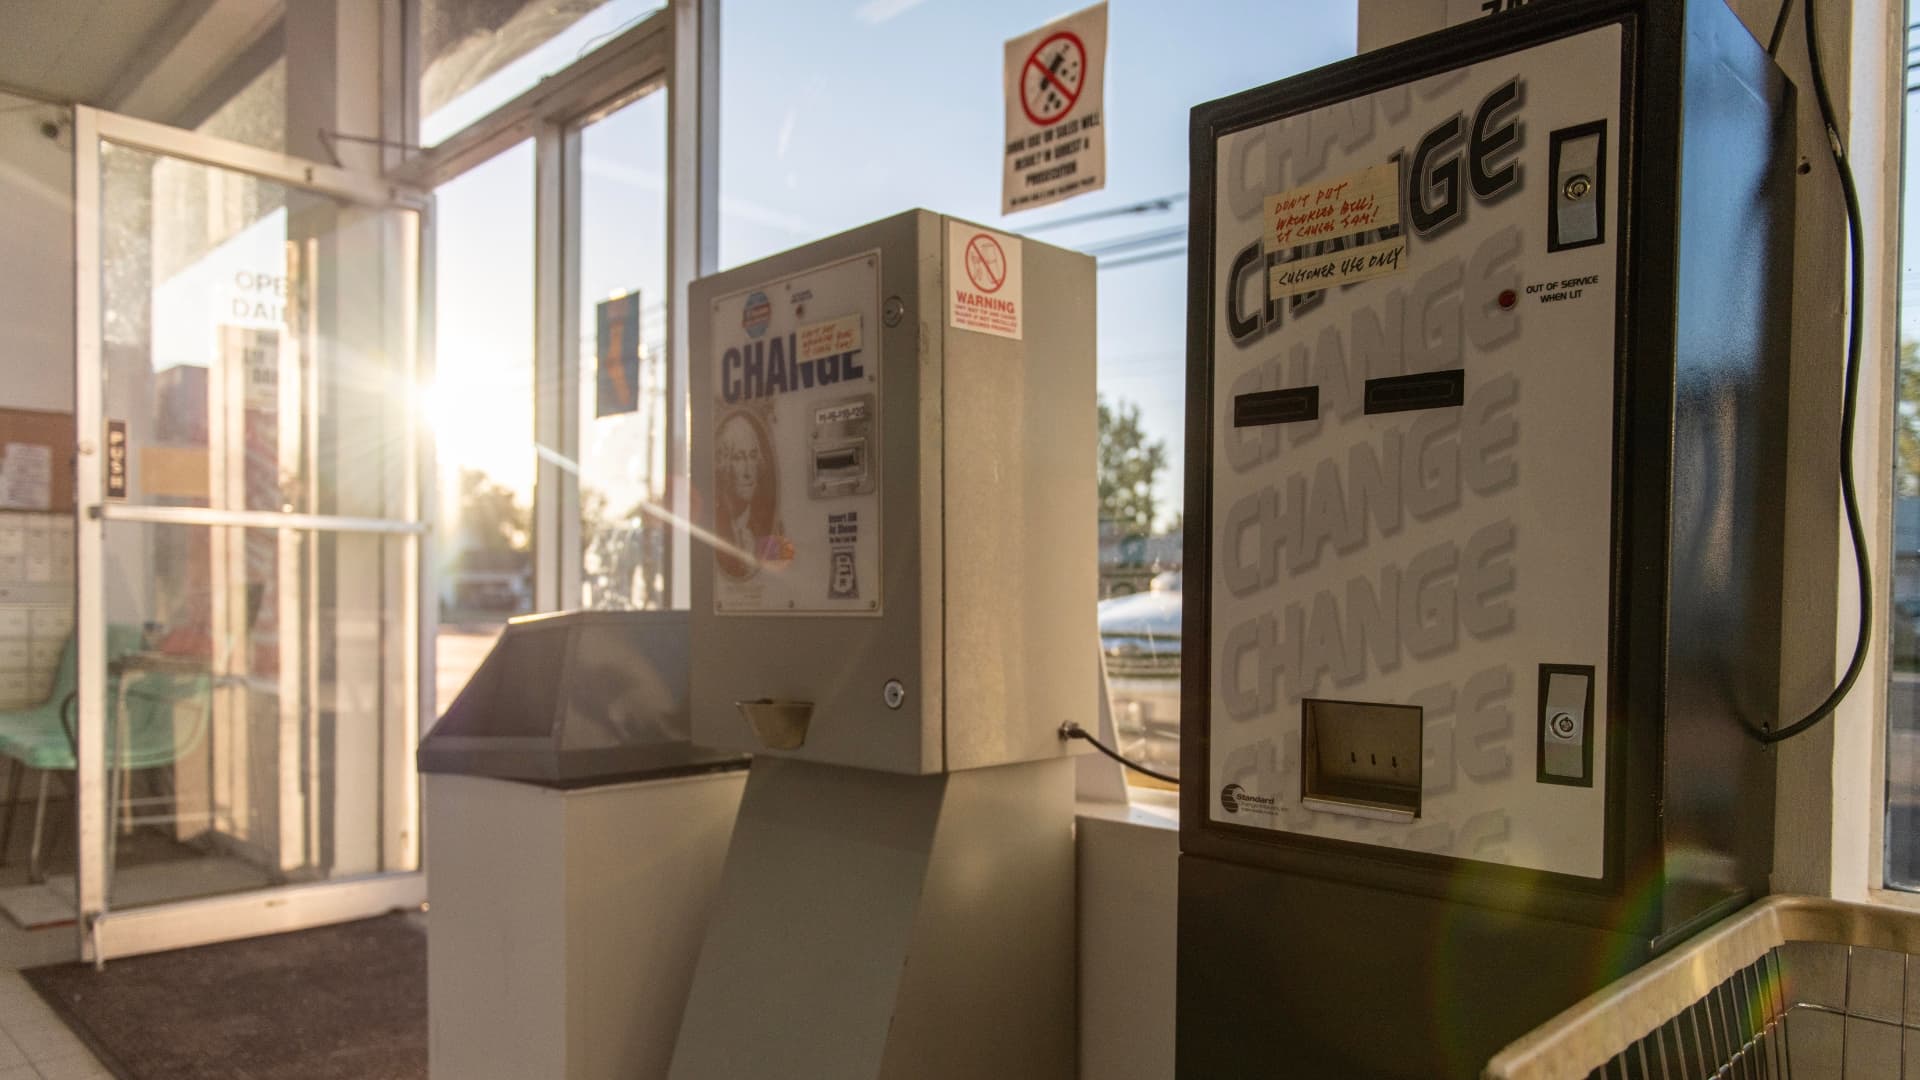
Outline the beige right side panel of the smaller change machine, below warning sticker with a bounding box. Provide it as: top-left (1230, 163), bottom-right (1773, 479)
top-left (940, 227), bottom-right (1100, 769)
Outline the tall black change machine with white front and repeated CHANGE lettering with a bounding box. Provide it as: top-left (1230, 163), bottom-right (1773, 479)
top-left (1177, 0), bottom-right (1795, 1078)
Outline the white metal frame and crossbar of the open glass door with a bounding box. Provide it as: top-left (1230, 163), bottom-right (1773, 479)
top-left (73, 106), bottom-right (436, 963)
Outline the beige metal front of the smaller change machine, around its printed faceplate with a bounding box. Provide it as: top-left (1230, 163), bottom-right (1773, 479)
top-left (687, 213), bottom-right (943, 773)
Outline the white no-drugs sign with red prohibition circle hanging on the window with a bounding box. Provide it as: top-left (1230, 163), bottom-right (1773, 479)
top-left (1000, 2), bottom-right (1106, 213)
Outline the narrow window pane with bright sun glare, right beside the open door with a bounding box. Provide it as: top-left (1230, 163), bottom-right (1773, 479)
top-left (428, 142), bottom-right (536, 711)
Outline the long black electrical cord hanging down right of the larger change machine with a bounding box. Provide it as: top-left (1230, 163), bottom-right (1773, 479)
top-left (1741, 0), bottom-right (1874, 744)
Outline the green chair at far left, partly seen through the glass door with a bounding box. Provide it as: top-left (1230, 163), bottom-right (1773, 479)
top-left (0, 625), bottom-right (211, 882)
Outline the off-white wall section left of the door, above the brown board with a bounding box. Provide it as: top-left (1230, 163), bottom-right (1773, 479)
top-left (0, 94), bottom-right (73, 413)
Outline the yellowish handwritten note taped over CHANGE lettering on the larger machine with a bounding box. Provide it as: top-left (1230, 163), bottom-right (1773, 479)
top-left (1261, 161), bottom-right (1407, 296)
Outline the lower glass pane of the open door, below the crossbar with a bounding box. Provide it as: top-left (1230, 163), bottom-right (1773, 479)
top-left (90, 521), bottom-right (415, 909)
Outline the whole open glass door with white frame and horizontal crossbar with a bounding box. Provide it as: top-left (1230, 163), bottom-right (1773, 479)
top-left (73, 110), bottom-right (426, 959)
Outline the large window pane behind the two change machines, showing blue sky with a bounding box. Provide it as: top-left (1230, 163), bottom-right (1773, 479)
top-left (720, 0), bottom-right (1356, 780)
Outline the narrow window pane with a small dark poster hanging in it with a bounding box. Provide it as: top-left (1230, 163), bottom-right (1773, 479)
top-left (576, 90), bottom-right (670, 609)
